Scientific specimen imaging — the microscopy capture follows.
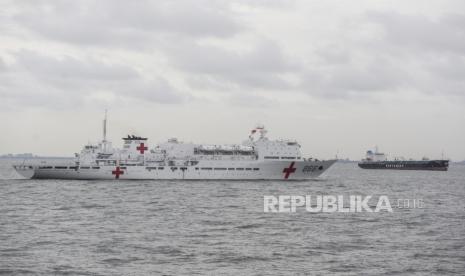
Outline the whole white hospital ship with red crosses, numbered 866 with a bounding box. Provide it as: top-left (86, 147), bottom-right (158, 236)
top-left (14, 113), bottom-right (336, 180)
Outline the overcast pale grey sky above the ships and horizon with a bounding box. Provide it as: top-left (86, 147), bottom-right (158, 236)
top-left (0, 0), bottom-right (465, 160)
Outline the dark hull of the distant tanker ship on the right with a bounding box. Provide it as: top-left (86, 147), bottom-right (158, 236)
top-left (358, 160), bottom-right (449, 171)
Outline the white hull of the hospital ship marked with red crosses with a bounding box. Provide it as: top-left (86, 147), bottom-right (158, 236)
top-left (15, 160), bottom-right (336, 180)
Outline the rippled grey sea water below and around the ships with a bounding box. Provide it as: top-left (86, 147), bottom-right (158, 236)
top-left (0, 160), bottom-right (465, 275)
